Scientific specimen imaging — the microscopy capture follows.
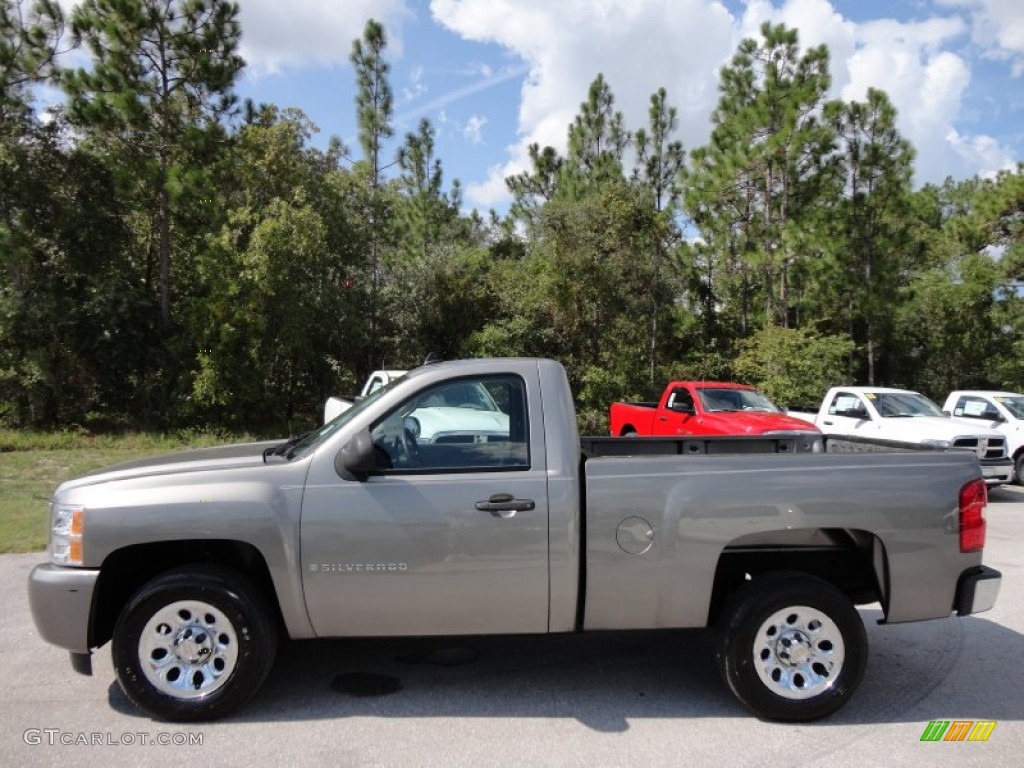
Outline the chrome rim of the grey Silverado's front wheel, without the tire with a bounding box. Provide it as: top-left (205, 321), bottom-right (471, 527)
top-left (138, 600), bottom-right (239, 699)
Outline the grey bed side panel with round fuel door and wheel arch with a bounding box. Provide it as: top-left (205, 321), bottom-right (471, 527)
top-left (585, 454), bottom-right (981, 629)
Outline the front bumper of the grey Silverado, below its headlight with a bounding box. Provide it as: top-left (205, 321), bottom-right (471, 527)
top-left (29, 563), bottom-right (99, 653)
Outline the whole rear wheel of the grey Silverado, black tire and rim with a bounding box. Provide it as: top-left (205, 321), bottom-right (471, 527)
top-left (715, 573), bottom-right (867, 722)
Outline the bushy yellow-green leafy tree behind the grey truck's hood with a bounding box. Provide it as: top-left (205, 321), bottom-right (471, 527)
top-left (189, 106), bottom-right (367, 428)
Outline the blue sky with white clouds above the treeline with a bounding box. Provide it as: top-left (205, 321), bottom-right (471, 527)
top-left (54, 0), bottom-right (1024, 217)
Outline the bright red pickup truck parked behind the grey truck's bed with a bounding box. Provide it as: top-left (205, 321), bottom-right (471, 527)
top-left (609, 381), bottom-right (819, 437)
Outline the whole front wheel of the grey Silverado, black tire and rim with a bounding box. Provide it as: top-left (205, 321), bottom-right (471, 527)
top-left (112, 565), bottom-right (278, 722)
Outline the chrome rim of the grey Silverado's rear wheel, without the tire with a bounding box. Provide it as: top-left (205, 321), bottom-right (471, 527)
top-left (753, 605), bottom-right (846, 700)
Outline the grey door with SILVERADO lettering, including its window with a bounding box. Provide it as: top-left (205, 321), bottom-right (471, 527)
top-left (301, 374), bottom-right (548, 637)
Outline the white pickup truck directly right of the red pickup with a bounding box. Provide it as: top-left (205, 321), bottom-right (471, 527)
top-left (790, 386), bottom-right (1014, 486)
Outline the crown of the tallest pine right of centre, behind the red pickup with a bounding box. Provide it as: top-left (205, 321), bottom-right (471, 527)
top-left (686, 23), bottom-right (838, 336)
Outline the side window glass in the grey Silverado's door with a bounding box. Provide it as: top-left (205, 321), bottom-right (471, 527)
top-left (371, 376), bottom-right (529, 472)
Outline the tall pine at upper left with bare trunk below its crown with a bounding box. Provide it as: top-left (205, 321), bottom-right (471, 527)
top-left (61, 0), bottom-right (244, 329)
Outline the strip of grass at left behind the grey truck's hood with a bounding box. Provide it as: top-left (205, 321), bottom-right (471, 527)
top-left (0, 429), bottom-right (252, 553)
